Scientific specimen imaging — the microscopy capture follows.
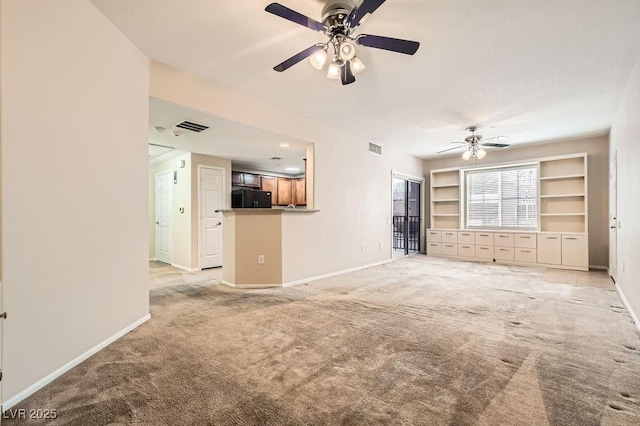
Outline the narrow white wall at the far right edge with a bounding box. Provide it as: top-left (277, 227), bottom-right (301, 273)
top-left (610, 57), bottom-right (640, 327)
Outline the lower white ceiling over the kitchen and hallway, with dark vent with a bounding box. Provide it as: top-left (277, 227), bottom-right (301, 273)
top-left (149, 98), bottom-right (309, 175)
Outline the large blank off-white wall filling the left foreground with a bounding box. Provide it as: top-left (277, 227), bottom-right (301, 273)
top-left (0, 0), bottom-right (149, 402)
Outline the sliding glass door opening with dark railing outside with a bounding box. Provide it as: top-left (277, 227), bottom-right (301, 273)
top-left (392, 174), bottom-right (423, 258)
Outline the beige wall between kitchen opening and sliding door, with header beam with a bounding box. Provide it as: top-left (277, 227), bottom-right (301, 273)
top-left (151, 63), bottom-right (423, 279)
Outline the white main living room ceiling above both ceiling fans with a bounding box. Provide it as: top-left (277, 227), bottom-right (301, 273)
top-left (92, 0), bottom-right (640, 157)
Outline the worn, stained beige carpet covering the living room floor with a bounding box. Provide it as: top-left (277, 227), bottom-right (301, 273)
top-left (5, 256), bottom-right (640, 426)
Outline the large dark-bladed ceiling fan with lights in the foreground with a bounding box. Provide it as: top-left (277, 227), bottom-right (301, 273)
top-left (265, 0), bottom-right (420, 85)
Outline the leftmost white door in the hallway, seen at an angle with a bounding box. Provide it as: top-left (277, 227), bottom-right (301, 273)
top-left (156, 170), bottom-right (173, 264)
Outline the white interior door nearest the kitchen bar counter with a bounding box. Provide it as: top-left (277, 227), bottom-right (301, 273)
top-left (199, 167), bottom-right (224, 269)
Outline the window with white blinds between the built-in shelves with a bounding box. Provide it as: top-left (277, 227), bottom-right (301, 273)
top-left (465, 164), bottom-right (538, 230)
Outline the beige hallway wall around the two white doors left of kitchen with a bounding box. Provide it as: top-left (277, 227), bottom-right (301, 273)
top-left (148, 153), bottom-right (231, 269)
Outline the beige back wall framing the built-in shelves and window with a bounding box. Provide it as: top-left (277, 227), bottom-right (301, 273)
top-left (424, 136), bottom-right (609, 267)
